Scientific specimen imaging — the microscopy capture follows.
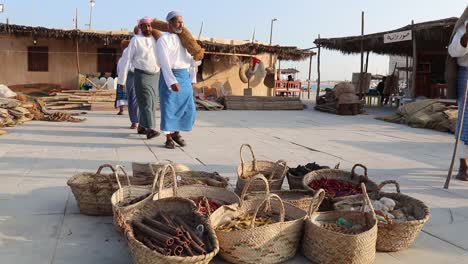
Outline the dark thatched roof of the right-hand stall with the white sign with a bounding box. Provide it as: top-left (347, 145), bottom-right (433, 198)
top-left (314, 17), bottom-right (458, 56)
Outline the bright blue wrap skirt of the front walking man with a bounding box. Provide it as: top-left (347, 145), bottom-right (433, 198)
top-left (159, 69), bottom-right (196, 131)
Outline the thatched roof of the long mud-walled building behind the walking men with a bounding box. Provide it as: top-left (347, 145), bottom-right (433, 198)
top-left (0, 23), bottom-right (315, 61)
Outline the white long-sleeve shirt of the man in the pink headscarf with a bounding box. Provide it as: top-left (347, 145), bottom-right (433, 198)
top-left (118, 35), bottom-right (159, 85)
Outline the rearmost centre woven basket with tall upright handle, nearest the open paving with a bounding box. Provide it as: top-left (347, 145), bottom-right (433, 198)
top-left (236, 144), bottom-right (288, 194)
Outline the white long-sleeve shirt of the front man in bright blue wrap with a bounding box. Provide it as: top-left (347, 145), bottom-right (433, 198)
top-left (156, 32), bottom-right (201, 89)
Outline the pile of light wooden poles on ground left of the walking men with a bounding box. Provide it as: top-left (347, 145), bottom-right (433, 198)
top-left (41, 90), bottom-right (115, 110)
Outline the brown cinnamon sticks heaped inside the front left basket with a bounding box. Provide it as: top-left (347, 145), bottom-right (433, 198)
top-left (132, 212), bottom-right (211, 257)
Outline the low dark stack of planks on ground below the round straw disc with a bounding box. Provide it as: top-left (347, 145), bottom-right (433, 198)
top-left (224, 95), bottom-right (304, 110)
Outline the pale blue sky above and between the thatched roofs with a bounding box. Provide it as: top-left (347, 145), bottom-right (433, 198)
top-left (0, 0), bottom-right (467, 80)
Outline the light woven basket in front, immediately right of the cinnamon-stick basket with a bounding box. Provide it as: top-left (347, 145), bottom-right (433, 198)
top-left (210, 194), bottom-right (305, 264)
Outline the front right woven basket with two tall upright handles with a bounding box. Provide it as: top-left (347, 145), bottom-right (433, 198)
top-left (302, 184), bottom-right (377, 264)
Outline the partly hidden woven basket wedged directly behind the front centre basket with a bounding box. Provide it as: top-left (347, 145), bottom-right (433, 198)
top-left (241, 174), bottom-right (314, 211)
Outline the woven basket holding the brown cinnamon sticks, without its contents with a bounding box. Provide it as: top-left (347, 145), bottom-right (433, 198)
top-left (126, 197), bottom-right (219, 264)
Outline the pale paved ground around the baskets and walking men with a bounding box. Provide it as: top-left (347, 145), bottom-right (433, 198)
top-left (0, 104), bottom-right (468, 264)
